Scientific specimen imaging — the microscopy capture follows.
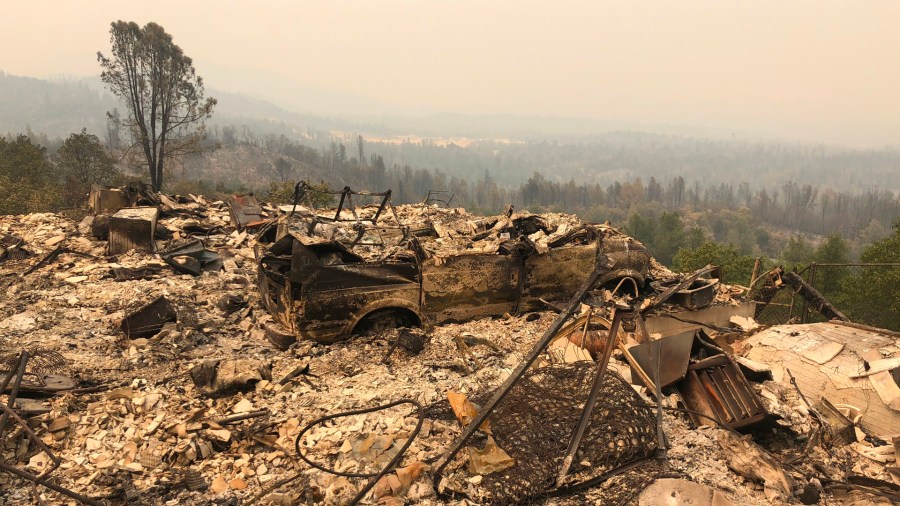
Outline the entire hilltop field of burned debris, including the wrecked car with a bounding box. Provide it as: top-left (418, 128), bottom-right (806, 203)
top-left (0, 183), bottom-right (900, 505)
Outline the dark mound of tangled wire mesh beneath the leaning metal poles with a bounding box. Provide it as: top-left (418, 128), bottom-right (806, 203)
top-left (432, 361), bottom-right (656, 504)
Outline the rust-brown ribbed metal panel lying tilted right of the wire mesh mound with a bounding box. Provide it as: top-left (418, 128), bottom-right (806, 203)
top-left (675, 354), bottom-right (768, 430)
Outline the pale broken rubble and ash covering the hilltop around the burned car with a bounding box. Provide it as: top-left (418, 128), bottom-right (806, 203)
top-left (0, 184), bottom-right (900, 505)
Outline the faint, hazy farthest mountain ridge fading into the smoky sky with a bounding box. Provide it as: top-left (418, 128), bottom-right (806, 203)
top-left (0, 71), bottom-right (744, 141)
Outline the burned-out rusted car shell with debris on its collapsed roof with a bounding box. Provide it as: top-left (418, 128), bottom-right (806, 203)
top-left (258, 189), bottom-right (650, 346)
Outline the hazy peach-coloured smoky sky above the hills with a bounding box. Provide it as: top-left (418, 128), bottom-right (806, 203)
top-left (0, 0), bottom-right (900, 146)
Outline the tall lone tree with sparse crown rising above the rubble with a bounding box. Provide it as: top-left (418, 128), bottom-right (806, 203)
top-left (97, 21), bottom-right (216, 191)
